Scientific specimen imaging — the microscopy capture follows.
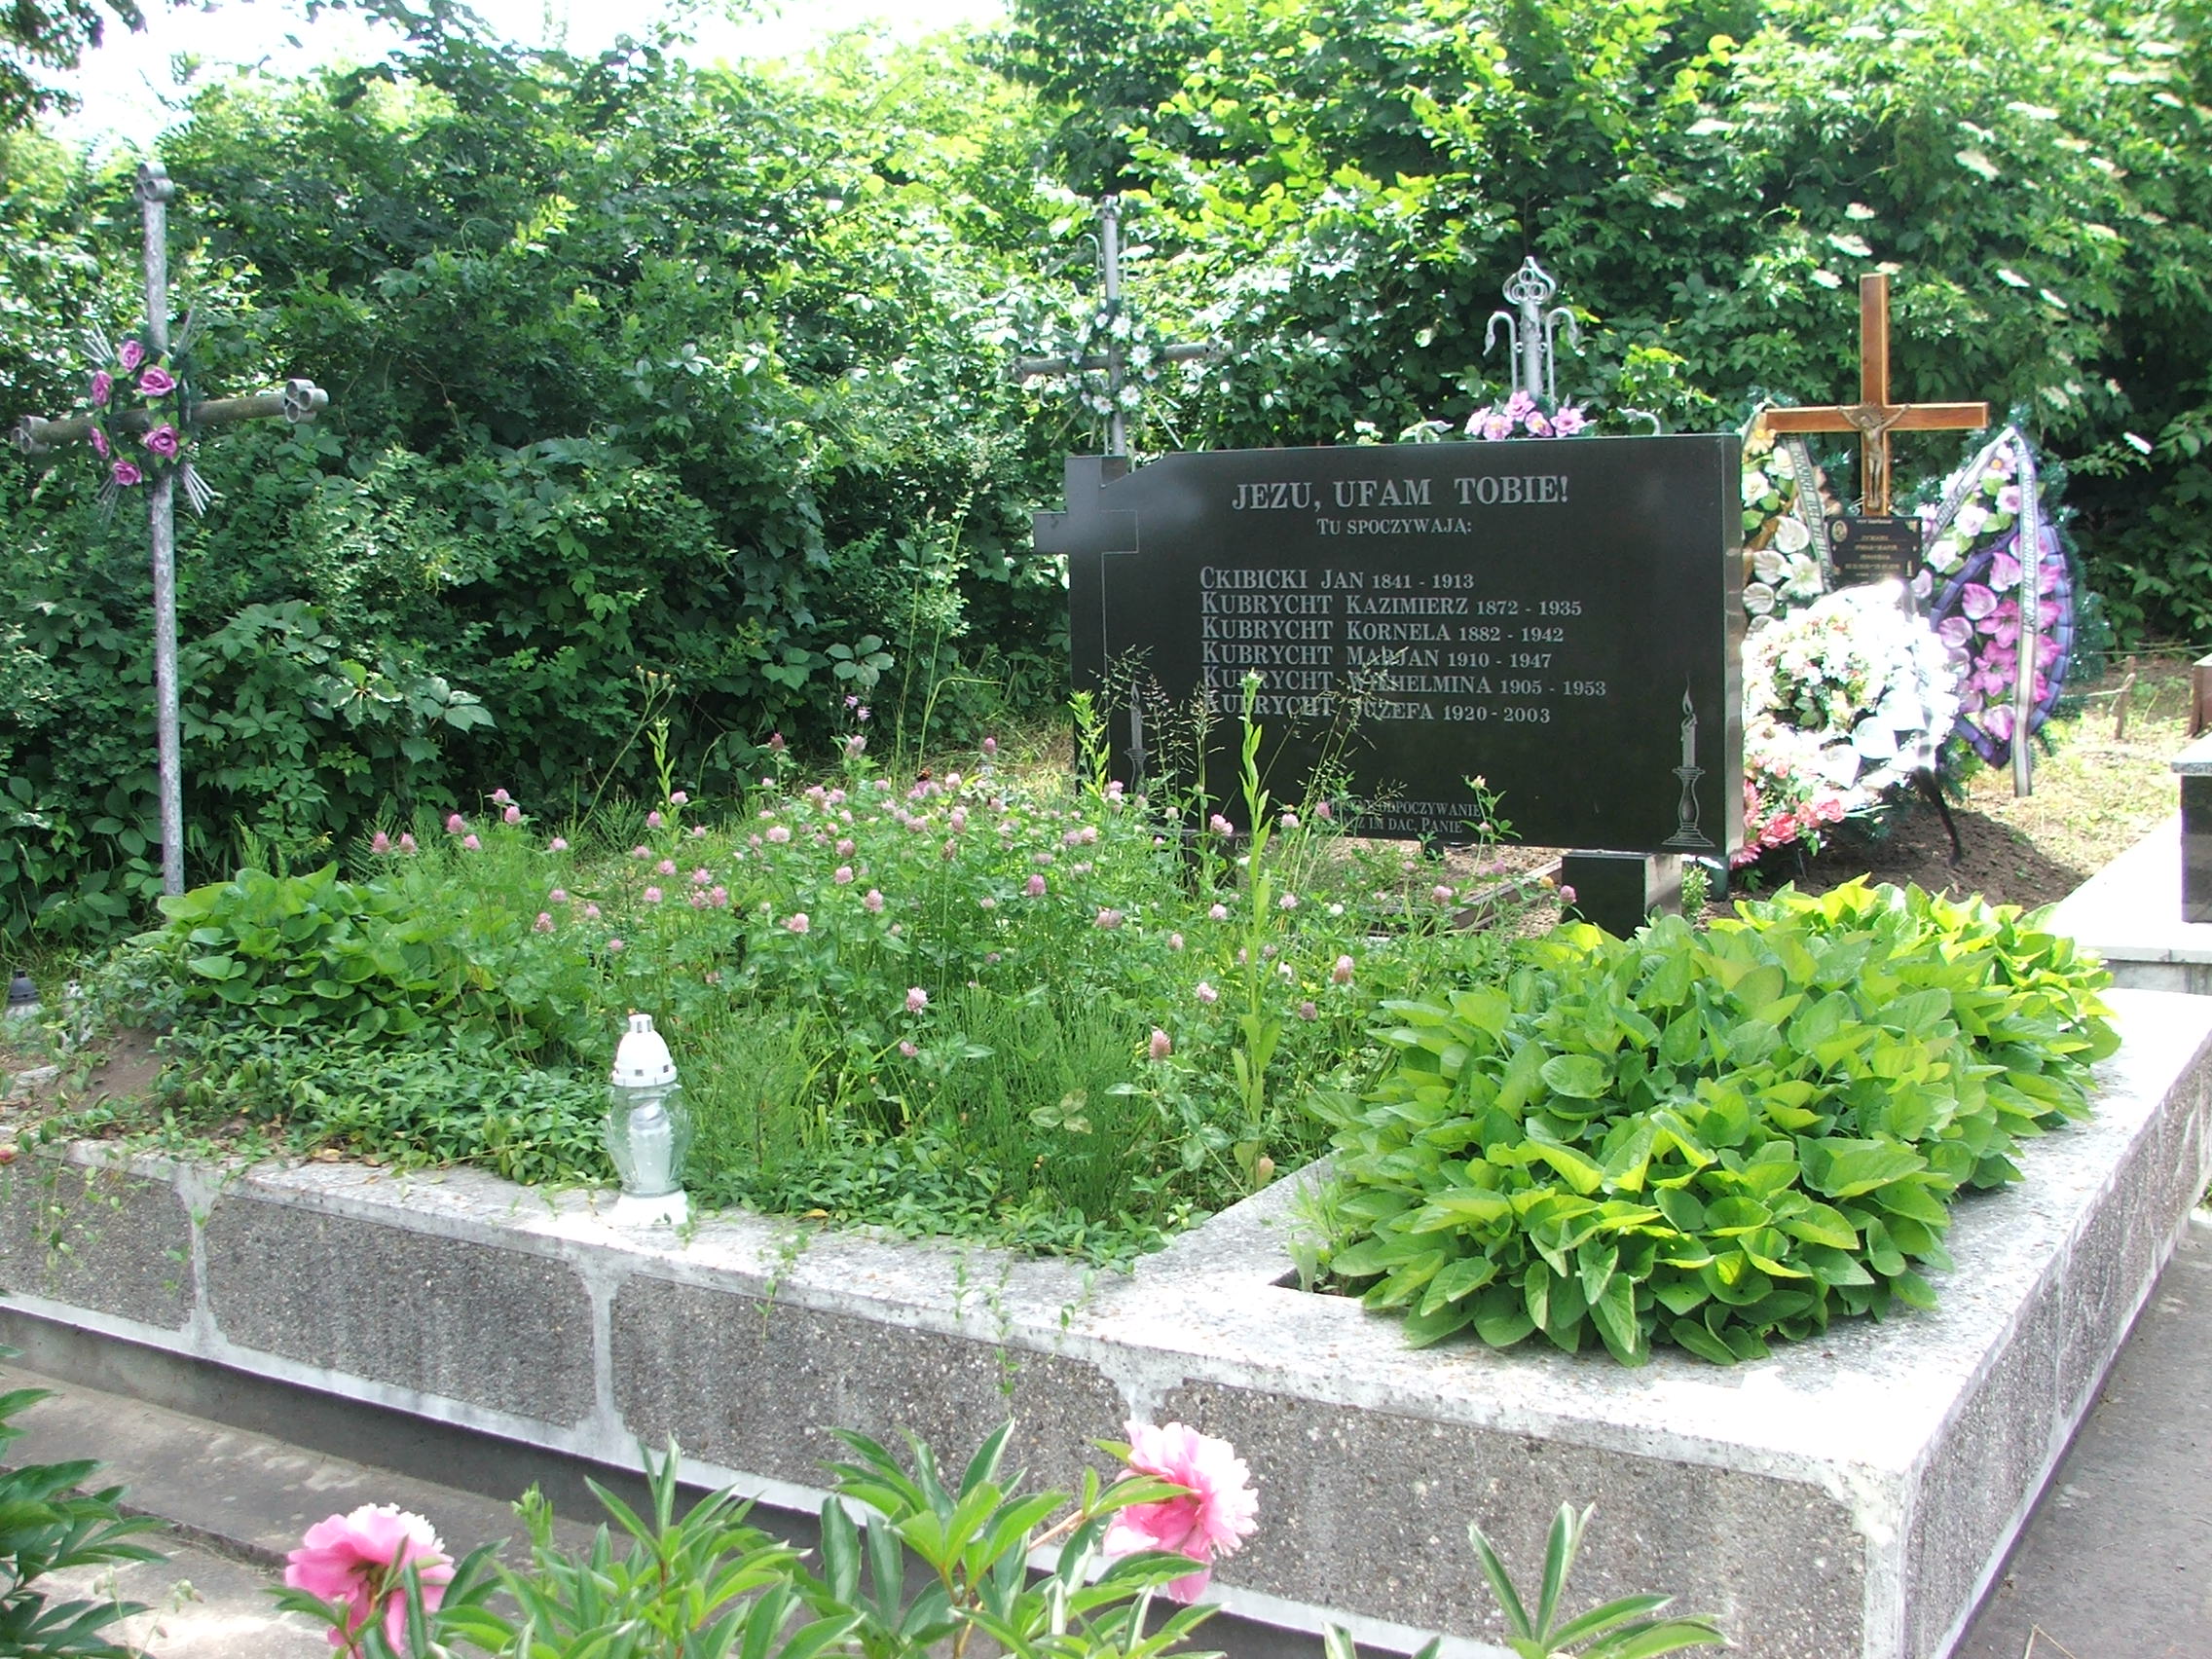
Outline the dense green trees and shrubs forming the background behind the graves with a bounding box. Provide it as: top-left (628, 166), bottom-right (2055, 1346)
top-left (0, 0), bottom-right (2212, 934)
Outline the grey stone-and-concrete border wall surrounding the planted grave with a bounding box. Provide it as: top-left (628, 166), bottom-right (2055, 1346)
top-left (0, 991), bottom-right (2212, 1659)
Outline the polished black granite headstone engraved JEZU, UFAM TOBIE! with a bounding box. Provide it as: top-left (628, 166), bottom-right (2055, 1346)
top-left (1038, 436), bottom-right (1743, 856)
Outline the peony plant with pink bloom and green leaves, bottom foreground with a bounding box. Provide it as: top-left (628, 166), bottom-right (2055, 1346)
top-left (276, 1424), bottom-right (1241, 1659)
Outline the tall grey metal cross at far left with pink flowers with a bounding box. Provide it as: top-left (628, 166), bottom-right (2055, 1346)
top-left (16, 162), bottom-right (330, 894)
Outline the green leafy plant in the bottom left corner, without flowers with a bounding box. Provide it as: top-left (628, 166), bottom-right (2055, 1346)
top-left (0, 1349), bottom-right (162, 1659)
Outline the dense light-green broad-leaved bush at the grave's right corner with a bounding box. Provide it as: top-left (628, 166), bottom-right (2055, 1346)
top-left (1323, 883), bottom-right (2117, 1365)
